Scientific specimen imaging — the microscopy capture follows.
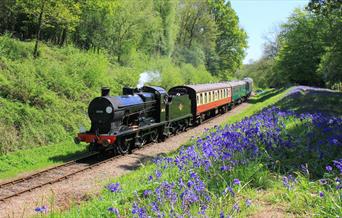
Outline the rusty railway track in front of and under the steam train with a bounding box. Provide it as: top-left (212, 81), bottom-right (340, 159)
top-left (0, 104), bottom-right (243, 202)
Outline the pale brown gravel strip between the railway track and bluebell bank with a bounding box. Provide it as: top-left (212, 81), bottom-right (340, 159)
top-left (0, 103), bottom-right (248, 218)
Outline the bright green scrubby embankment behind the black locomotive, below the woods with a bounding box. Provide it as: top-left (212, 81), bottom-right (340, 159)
top-left (0, 36), bottom-right (216, 153)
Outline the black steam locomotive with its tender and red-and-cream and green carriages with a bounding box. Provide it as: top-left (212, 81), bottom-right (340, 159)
top-left (75, 78), bottom-right (253, 154)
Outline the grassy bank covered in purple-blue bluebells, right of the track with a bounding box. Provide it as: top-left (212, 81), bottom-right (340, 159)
top-left (44, 89), bottom-right (342, 217)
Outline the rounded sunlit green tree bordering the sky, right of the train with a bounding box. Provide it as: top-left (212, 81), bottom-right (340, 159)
top-left (276, 9), bottom-right (326, 86)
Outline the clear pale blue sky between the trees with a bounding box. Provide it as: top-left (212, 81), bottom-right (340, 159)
top-left (230, 0), bottom-right (309, 63)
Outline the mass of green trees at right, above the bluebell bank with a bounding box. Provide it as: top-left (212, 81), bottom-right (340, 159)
top-left (236, 0), bottom-right (342, 90)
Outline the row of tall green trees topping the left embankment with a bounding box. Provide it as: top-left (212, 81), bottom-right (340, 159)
top-left (0, 0), bottom-right (246, 79)
